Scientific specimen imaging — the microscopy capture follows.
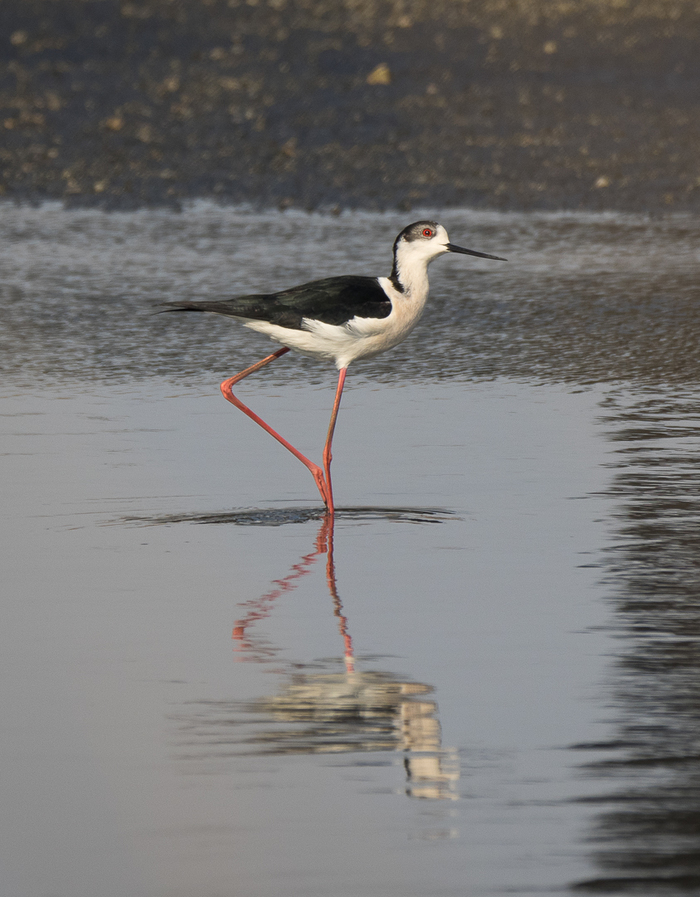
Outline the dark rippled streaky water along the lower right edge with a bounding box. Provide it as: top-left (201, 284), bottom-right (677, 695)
top-left (579, 388), bottom-right (700, 893)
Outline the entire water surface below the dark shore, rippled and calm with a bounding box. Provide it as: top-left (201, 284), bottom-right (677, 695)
top-left (0, 205), bottom-right (700, 897)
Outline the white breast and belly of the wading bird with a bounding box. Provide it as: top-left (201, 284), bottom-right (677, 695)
top-left (241, 277), bottom-right (428, 369)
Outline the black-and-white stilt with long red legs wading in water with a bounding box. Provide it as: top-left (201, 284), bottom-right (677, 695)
top-left (164, 221), bottom-right (506, 518)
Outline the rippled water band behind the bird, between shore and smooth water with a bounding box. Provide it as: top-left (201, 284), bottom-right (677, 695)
top-left (2, 203), bottom-right (700, 384)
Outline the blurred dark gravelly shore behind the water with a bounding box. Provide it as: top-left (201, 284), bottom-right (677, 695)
top-left (0, 0), bottom-right (700, 213)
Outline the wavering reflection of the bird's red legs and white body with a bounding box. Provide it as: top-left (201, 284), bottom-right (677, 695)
top-left (181, 515), bottom-right (459, 799)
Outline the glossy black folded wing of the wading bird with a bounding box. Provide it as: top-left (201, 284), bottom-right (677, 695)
top-left (166, 275), bottom-right (391, 330)
